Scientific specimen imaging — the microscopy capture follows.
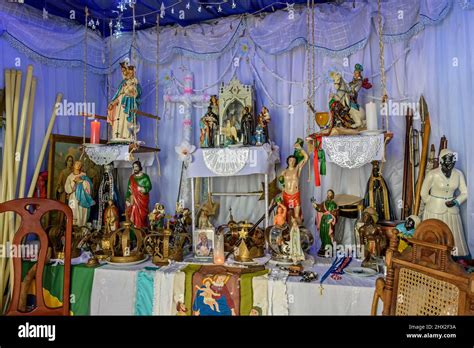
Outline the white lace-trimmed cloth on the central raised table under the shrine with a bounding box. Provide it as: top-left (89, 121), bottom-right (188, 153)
top-left (188, 144), bottom-right (280, 180)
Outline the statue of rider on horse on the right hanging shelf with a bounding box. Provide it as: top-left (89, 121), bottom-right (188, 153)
top-left (329, 64), bottom-right (372, 128)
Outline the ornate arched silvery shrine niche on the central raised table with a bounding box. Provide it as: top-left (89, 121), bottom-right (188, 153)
top-left (219, 77), bottom-right (255, 146)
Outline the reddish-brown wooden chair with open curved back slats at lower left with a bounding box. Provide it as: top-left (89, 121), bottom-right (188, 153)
top-left (0, 198), bottom-right (72, 315)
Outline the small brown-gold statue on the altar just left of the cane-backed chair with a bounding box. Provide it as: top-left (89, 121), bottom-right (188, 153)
top-left (359, 207), bottom-right (387, 271)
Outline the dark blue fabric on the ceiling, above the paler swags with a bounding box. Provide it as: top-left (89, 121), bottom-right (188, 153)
top-left (25, 0), bottom-right (332, 36)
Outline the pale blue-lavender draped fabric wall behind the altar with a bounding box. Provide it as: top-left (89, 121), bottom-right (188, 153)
top-left (0, 0), bottom-right (474, 256)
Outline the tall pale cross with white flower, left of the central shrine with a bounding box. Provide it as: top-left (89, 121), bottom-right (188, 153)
top-left (163, 72), bottom-right (210, 207)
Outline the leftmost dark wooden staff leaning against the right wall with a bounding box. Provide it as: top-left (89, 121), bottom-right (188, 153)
top-left (401, 109), bottom-right (413, 220)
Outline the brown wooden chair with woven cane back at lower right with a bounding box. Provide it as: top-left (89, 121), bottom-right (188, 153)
top-left (372, 219), bottom-right (474, 315)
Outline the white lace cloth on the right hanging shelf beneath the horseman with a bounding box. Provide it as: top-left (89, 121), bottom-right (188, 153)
top-left (323, 134), bottom-right (384, 169)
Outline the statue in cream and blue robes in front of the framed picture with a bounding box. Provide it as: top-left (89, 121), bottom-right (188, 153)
top-left (64, 161), bottom-right (95, 227)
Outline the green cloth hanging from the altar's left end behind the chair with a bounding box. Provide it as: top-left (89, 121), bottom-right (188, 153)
top-left (22, 261), bottom-right (95, 315)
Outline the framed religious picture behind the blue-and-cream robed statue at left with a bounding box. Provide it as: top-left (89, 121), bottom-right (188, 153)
top-left (47, 134), bottom-right (105, 225)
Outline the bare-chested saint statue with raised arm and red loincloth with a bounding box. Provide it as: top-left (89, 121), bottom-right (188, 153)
top-left (279, 141), bottom-right (308, 224)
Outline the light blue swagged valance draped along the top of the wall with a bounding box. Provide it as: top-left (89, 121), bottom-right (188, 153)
top-left (0, 0), bottom-right (474, 74)
